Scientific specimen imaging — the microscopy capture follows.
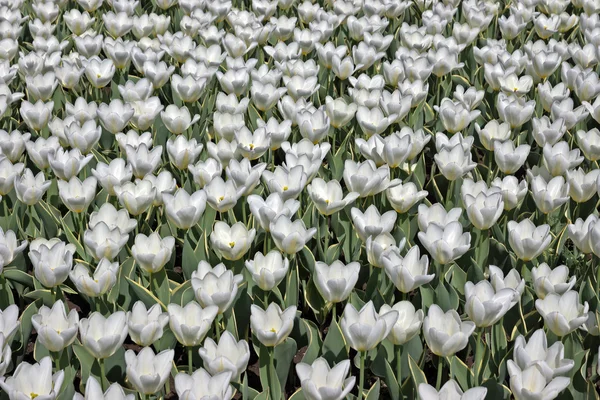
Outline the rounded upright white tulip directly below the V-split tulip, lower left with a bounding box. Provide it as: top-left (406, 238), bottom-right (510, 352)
top-left (79, 311), bottom-right (127, 359)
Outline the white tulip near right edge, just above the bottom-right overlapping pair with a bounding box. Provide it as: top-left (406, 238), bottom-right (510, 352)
top-left (535, 290), bottom-right (589, 336)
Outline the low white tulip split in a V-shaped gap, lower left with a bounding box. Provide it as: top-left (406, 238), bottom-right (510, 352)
top-left (69, 258), bottom-right (119, 297)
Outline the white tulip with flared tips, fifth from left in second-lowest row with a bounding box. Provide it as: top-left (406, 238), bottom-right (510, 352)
top-left (167, 301), bottom-right (219, 347)
